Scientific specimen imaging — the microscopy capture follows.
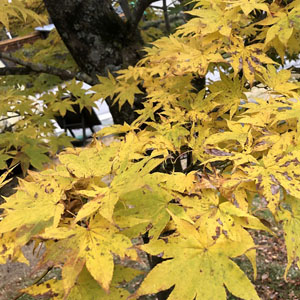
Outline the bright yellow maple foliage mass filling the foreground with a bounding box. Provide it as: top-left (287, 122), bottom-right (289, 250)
top-left (0, 0), bottom-right (300, 300)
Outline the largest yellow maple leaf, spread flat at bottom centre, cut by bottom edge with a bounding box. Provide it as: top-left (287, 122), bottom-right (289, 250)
top-left (134, 213), bottom-right (259, 300)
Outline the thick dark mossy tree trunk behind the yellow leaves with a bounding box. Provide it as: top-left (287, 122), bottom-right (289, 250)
top-left (44, 0), bottom-right (143, 124)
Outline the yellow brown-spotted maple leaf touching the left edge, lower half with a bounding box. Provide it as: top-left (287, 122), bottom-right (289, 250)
top-left (0, 180), bottom-right (64, 244)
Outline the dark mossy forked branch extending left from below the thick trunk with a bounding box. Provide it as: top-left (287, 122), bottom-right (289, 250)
top-left (0, 52), bottom-right (97, 85)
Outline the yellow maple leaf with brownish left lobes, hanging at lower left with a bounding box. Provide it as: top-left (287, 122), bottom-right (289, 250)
top-left (39, 214), bottom-right (136, 295)
